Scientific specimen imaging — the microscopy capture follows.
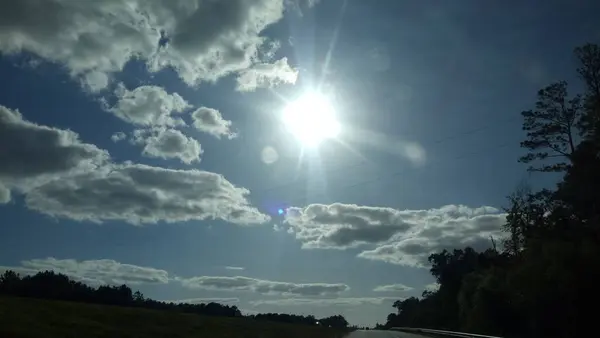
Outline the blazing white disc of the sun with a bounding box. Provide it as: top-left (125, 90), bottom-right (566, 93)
top-left (283, 93), bottom-right (341, 146)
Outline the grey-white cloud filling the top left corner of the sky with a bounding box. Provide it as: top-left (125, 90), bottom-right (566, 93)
top-left (0, 0), bottom-right (160, 89)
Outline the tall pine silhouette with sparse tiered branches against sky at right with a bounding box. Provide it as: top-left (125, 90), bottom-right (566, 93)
top-left (519, 81), bottom-right (583, 172)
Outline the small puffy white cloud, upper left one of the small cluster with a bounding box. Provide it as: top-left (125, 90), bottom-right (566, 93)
top-left (108, 84), bottom-right (192, 126)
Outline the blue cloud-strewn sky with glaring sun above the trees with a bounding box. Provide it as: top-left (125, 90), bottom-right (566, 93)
top-left (0, 0), bottom-right (600, 325)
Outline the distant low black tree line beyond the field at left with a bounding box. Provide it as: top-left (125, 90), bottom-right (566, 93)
top-left (0, 270), bottom-right (348, 328)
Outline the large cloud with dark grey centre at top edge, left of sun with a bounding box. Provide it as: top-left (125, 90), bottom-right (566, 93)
top-left (146, 0), bottom-right (284, 85)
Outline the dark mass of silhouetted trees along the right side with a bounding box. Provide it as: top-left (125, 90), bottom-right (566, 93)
top-left (385, 44), bottom-right (600, 337)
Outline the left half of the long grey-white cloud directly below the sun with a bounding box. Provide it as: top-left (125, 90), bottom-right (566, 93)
top-left (285, 203), bottom-right (412, 249)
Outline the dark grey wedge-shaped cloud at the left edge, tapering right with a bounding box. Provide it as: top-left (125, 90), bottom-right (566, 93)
top-left (0, 106), bottom-right (109, 195)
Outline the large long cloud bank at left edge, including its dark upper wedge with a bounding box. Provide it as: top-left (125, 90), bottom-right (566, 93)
top-left (0, 106), bottom-right (269, 224)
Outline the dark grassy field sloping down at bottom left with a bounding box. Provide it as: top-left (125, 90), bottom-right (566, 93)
top-left (0, 297), bottom-right (344, 338)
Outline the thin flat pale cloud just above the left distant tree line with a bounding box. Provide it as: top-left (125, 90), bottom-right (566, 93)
top-left (0, 257), bottom-right (169, 285)
